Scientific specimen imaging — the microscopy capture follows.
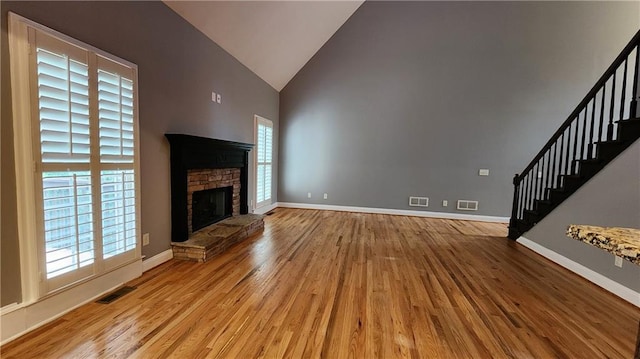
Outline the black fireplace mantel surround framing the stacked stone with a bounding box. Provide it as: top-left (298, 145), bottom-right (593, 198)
top-left (165, 134), bottom-right (253, 242)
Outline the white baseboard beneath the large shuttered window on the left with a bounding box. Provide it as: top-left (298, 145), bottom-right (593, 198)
top-left (0, 260), bottom-right (142, 345)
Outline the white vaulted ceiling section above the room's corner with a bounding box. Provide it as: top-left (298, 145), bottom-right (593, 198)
top-left (164, 0), bottom-right (364, 91)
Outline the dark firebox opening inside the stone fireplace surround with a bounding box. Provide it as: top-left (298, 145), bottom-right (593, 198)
top-left (191, 186), bottom-right (233, 232)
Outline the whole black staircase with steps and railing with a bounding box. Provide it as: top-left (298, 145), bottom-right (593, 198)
top-left (508, 31), bottom-right (640, 239)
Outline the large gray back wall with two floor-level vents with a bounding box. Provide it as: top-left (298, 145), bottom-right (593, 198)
top-left (278, 1), bottom-right (640, 217)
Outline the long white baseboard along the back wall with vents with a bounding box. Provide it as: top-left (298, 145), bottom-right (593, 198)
top-left (277, 202), bottom-right (509, 223)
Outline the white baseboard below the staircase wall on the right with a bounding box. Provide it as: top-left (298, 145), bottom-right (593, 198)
top-left (517, 237), bottom-right (640, 307)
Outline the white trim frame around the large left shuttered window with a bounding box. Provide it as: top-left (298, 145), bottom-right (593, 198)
top-left (8, 12), bottom-right (142, 306)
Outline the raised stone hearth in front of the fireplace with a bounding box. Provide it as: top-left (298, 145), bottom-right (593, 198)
top-left (171, 214), bottom-right (264, 262)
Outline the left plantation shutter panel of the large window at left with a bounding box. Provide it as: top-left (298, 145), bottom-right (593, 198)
top-left (35, 32), bottom-right (95, 287)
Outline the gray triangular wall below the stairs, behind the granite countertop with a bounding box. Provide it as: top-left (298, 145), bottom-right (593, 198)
top-left (523, 141), bottom-right (640, 292)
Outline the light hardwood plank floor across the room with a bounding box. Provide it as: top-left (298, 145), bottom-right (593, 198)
top-left (1, 209), bottom-right (640, 359)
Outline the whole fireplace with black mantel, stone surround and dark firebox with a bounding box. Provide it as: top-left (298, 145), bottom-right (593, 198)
top-left (165, 134), bottom-right (253, 242)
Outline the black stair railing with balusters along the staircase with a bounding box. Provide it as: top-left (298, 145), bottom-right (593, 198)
top-left (509, 31), bottom-right (640, 239)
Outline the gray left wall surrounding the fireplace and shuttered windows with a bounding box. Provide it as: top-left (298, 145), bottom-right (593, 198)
top-left (0, 1), bottom-right (279, 305)
